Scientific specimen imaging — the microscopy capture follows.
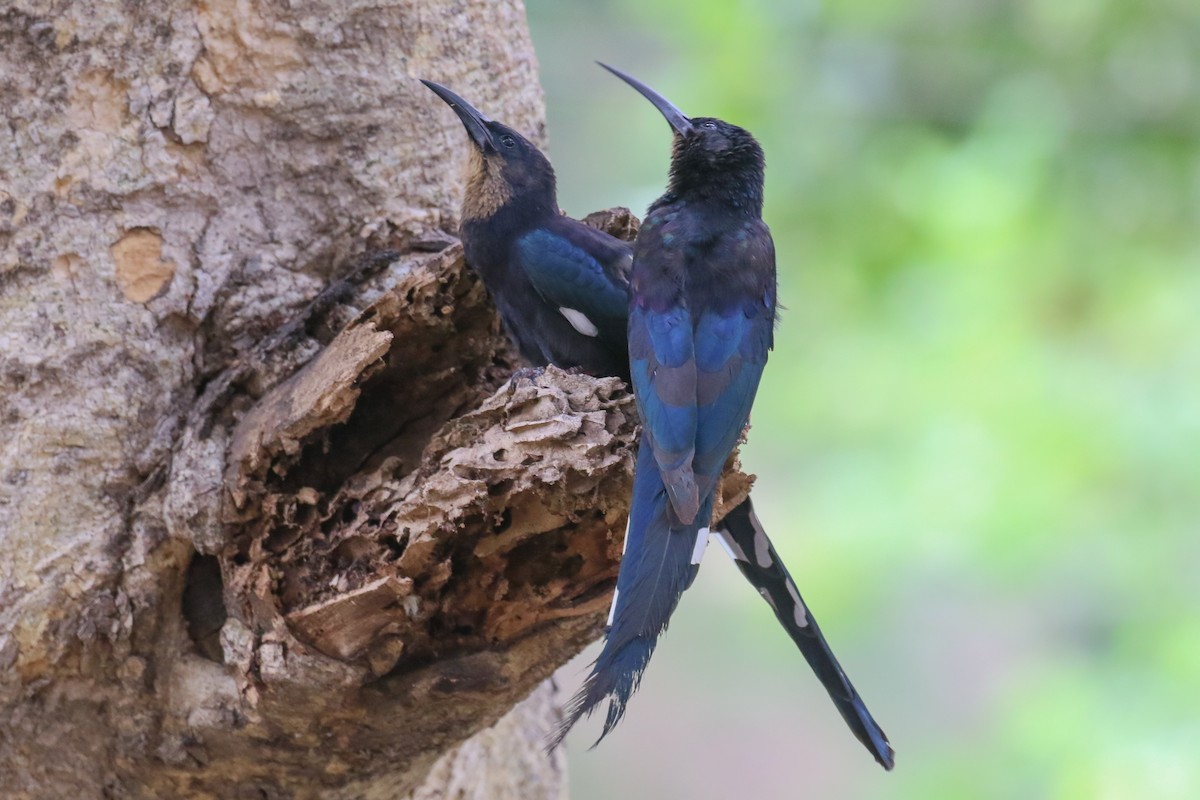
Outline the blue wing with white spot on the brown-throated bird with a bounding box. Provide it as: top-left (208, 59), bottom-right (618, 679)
top-left (516, 224), bottom-right (632, 341)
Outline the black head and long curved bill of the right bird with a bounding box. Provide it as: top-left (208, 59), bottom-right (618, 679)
top-left (600, 64), bottom-right (764, 204)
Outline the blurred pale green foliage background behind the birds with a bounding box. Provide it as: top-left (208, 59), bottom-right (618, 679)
top-left (528, 0), bottom-right (1200, 800)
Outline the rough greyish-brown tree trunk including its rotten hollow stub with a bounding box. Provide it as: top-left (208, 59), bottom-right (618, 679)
top-left (0, 0), bottom-right (745, 799)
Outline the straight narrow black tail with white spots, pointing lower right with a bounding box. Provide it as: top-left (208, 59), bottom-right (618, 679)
top-left (714, 498), bottom-right (895, 770)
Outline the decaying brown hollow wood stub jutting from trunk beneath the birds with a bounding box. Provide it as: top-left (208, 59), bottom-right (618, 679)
top-left (168, 226), bottom-right (749, 796)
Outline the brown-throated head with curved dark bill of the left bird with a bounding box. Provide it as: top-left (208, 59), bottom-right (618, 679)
top-left (421, 80), bottom-right (557, 219)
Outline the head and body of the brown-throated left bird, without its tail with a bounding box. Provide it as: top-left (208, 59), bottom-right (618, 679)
top-left (421, 80), bottom-right (632, 381)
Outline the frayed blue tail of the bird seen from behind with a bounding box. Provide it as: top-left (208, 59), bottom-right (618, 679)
top-left (550, 441), bottom-right (713, 750)
